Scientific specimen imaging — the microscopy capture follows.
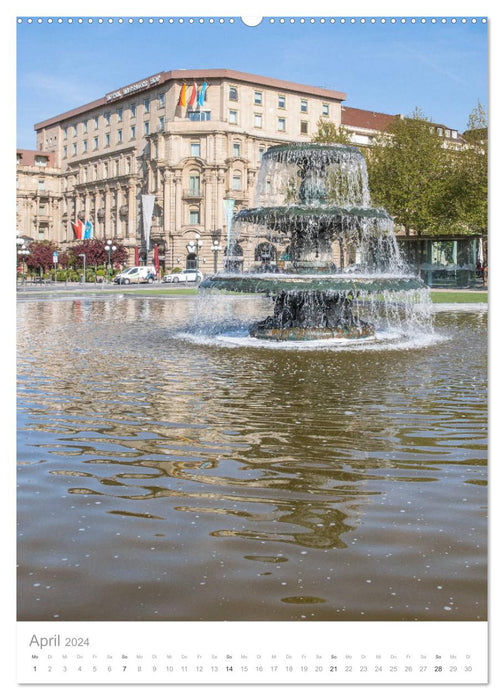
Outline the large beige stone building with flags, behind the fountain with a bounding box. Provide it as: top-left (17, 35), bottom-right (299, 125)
top-left (23, 69), bottom-right (345, 274)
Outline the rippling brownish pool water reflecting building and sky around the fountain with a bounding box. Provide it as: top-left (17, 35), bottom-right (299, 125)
top-left (18, 296), bottom-right (486, 619)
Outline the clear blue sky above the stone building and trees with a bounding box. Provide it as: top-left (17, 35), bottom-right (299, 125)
top-left (16, 15), bottom-right (488, 148)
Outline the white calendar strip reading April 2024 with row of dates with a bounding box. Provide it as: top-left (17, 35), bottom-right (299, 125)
top-left (18, 622), bottom-right (487, 684)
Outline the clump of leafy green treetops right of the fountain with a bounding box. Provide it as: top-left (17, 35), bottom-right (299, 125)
top-left (366, 104), bottom-right (488, 236)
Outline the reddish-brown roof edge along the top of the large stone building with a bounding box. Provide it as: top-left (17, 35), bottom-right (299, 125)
top-left (34, 68), bottom-right (346, 131)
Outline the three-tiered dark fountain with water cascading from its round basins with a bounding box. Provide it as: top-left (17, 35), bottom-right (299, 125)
top-left (201, 143), bottom-right (425, 341)
